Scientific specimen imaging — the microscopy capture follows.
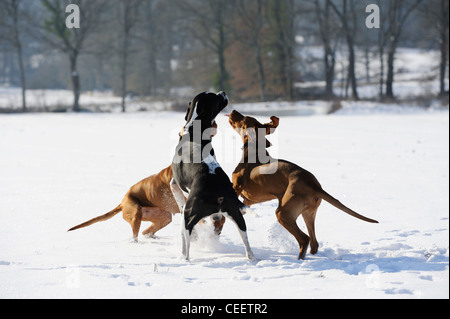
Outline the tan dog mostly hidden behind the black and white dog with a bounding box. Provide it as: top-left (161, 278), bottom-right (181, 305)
top-left (68, 122), bottom-right (225, 241)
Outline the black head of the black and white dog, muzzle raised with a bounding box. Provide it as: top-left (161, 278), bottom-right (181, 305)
top-left (184, 92), bottom-right (228, 131)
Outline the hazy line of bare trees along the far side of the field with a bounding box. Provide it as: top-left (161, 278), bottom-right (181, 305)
top-left (0, 0), bottom-right (449, 111)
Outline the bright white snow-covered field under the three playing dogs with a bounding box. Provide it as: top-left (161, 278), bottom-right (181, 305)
top-left (0, 104), bottom-right (449, 299)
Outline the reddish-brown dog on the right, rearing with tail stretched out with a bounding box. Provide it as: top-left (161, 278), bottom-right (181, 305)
top-left (229, 111), bottom-right (378, 259)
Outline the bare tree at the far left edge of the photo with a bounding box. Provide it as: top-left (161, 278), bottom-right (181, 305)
top-left (0, 0), bottom-right (27, 112)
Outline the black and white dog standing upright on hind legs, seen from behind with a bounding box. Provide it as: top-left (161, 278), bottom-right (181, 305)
top-left (171, 92), bottom-right (254, 260)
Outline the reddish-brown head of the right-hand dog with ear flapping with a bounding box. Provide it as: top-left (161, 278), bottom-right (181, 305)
top-left (229, 110), bottom-right (280, 147)
